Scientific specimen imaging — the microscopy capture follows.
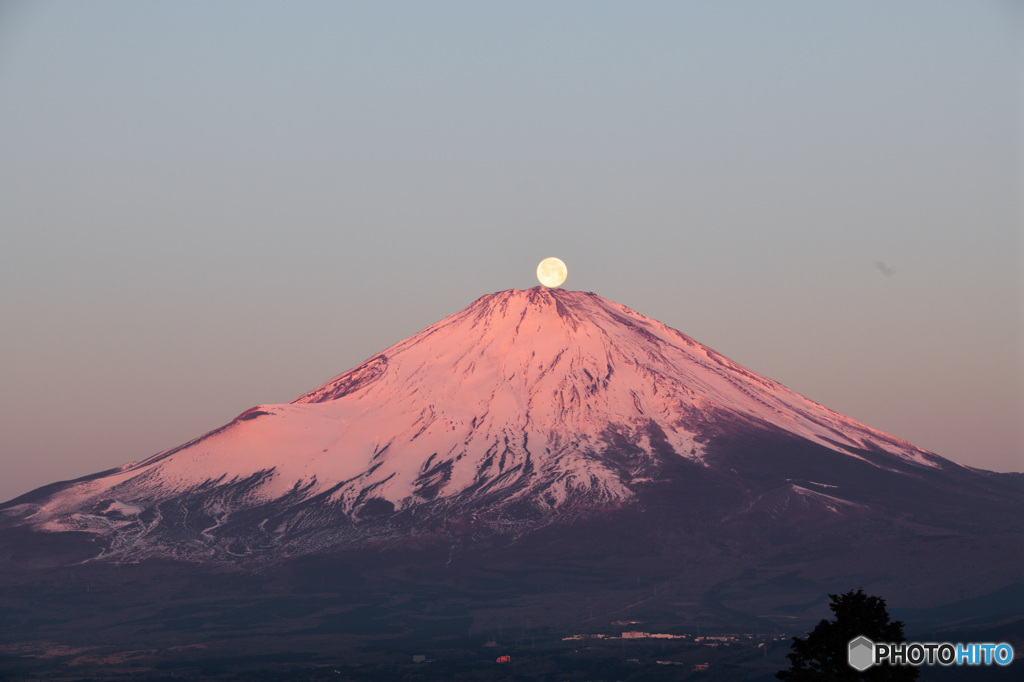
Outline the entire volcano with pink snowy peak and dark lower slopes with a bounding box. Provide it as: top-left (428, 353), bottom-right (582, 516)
top-left (0, 288), bottom-right (1024, 679)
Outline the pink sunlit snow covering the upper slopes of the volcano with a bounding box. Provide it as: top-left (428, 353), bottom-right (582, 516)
top-left (14, 287), bottom-right (933, 529)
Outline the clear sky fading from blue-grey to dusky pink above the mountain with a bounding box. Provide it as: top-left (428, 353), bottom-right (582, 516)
top-left (0, 0), bottom-right (1024, 500)
